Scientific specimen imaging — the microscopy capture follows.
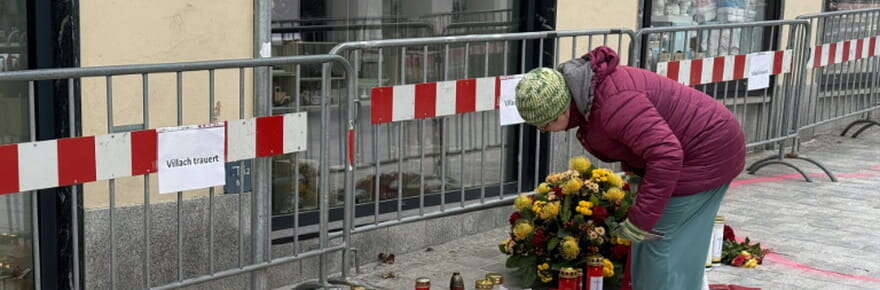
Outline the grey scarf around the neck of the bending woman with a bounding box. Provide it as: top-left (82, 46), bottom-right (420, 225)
top-left (556, 56), bottom-right (593, 121)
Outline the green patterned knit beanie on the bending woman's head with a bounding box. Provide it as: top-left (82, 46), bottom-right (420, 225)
top-left (516, 67), bottom-right (571, 127)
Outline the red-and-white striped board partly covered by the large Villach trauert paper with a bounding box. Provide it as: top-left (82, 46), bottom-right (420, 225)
top-left (0, 112), bottom-right (307, 194)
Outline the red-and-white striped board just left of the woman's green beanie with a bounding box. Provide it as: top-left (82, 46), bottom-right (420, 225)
top-left (370, 77), bottom-right (501, 124)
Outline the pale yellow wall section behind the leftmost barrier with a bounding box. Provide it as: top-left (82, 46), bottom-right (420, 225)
top-left (80, 0), bottom-right (253, 208)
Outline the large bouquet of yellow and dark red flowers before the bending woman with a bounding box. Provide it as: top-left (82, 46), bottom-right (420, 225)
top-left (499, 157), bottom-right (634, 288)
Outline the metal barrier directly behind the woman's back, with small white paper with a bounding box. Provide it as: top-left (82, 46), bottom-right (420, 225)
top-left (633, 20), bottom-right (834, 181)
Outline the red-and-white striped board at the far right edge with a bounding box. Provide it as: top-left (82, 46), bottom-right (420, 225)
top-left (807, 36), bottom-right (880, 67)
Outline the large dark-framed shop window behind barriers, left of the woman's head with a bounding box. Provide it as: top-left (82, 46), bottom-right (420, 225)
top-left (272, 0), bottom-right (520, 219)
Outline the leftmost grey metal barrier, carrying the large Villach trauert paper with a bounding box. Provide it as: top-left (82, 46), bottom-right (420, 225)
top-left (0, 55), bottom-right (353, 289)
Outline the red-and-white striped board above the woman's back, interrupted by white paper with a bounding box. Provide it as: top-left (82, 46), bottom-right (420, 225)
top-left (657, 50), bottom-right (792, 86)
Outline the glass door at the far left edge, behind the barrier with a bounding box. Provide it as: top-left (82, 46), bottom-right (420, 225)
top-left (0, 0), bottom-right (34, 289)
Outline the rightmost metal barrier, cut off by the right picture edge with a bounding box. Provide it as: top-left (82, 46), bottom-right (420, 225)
top-left (798, 8), bottom-right (880, 138)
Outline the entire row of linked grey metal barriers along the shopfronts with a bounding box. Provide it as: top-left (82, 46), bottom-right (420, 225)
top-left (6, 15), bottom-right (880, 289)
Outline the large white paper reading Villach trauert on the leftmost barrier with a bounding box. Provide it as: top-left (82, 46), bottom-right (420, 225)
top-left (157, 124), bottom-right (226, 193)
